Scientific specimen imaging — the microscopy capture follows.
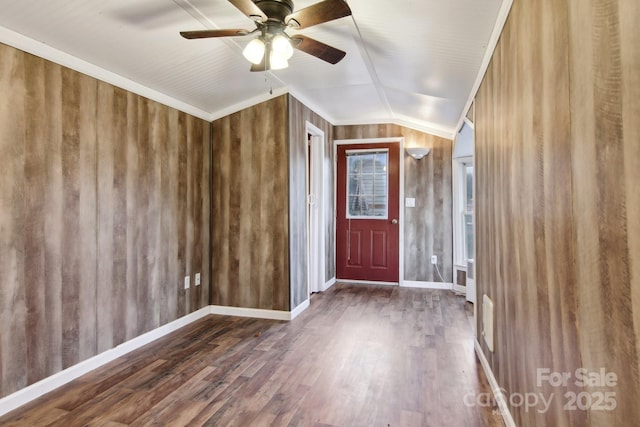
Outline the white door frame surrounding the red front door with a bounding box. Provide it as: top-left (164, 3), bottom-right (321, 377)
top-left (333, 137), bottom-right (404, 286)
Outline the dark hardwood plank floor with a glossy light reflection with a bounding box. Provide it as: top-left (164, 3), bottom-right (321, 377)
top-left (0, 284), bottom-right (503, 427)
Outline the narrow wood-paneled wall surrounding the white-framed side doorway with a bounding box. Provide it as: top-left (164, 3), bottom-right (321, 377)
top-left (289, 95), bottom-right (336, 308)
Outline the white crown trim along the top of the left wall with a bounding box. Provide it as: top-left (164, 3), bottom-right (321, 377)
top-left (0, 26), bottom-right (211, 121)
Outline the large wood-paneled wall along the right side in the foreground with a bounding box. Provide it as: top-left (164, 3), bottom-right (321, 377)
top-left (475, 0), bottom-right (640, 426)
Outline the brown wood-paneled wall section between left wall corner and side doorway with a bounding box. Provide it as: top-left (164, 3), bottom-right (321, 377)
top-left (212, 95), bottom-right (290, 311)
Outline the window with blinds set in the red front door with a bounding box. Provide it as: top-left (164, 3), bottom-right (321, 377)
top-left (347, 150), bottom-right (389, 219)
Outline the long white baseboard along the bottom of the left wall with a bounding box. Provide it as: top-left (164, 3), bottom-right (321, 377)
top-left (0, 306), bottom-right (210, 416)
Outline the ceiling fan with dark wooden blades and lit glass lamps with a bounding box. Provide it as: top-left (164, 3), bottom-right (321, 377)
top-left (180, 0), bottom-right (351, 71)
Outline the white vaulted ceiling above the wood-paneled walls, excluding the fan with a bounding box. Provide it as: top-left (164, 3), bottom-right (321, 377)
top-left (0, 0), bottom-right (510, 138)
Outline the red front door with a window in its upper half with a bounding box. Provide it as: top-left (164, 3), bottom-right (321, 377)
top-left (336, 143), bottom-right (400, 282)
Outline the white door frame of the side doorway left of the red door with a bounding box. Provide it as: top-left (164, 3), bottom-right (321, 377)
top-left (305, 122), bottom-right (326, 295)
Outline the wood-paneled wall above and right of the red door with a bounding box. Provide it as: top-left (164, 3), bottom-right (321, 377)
top-left (334, 124), bottom-right (453, 283)
